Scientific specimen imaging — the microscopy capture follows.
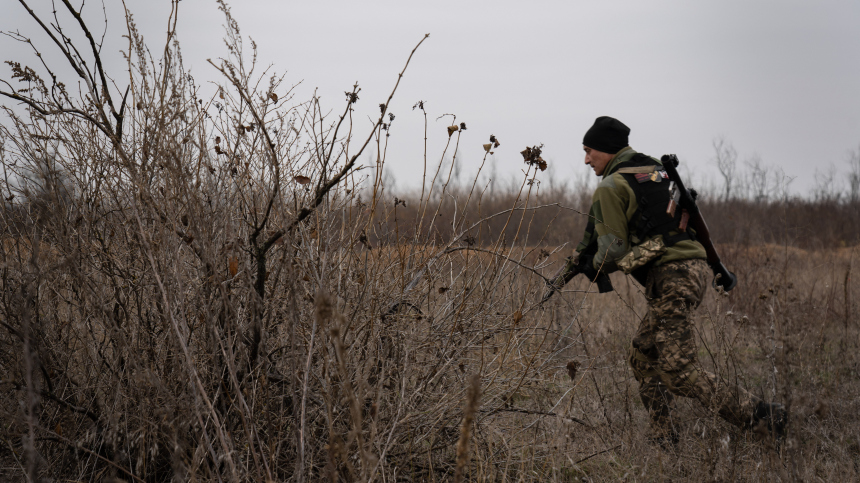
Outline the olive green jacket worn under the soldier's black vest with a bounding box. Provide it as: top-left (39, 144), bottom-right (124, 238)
top-left (576, 146), bottom-right (707, 273)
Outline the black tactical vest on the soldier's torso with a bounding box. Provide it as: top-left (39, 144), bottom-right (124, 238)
top-left (615, 153), bottom-right (696, 247)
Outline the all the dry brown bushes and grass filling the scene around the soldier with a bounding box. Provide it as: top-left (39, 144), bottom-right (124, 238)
top-left (0, 2), bottom-right (860, 481)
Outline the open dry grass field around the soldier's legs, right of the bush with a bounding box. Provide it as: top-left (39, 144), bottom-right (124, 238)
top-left (524, 245), bottom-right (860, 481)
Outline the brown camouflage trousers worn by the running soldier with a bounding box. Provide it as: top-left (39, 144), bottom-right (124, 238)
top-left (629, 260), bottom-right (759, 439)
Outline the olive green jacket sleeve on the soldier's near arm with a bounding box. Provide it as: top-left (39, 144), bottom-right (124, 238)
top-left (591, 174), bottom-right (636, 273)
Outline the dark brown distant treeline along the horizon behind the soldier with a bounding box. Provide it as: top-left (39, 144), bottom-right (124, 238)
top-left (368, 185), bottom-right (860, 249)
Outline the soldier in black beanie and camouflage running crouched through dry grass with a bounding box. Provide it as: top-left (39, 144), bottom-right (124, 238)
top-left (574, 116), bottom-right (788, 445)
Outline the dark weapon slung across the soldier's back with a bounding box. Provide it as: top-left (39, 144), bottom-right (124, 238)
top-left (660, 154), bottom-right (738, 292)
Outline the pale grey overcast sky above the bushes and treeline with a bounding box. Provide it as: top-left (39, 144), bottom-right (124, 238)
top-left (0, 0), bottom-right (860, 194)
